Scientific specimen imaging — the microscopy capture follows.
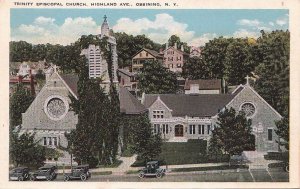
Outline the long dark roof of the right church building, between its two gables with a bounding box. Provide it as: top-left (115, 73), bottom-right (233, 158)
top-left (144, 94), bottom-right (235, 117)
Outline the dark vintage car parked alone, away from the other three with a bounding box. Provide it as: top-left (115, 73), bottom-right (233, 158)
top-left (139, 161), bottom-right (166, 178)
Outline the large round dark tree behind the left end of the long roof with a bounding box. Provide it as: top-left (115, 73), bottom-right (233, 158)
top-left (138, 61), bottom-right (178, 94)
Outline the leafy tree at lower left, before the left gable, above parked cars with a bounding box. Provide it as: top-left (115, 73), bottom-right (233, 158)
top-left (9, 129), bottom-right (46, 167)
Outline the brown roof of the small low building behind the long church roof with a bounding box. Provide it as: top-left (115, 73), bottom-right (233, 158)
top-left (184, 79), bottom-right (222, 90)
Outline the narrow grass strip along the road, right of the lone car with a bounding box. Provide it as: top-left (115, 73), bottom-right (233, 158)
top-left (172, 165), bottom-right (249, 172)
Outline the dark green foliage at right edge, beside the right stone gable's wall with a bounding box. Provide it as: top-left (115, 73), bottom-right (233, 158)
top-left (275, 118), bottom-right (290, 150)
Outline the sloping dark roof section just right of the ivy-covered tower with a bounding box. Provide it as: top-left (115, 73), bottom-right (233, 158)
top-left (119, 87), bottom-right (147, 114)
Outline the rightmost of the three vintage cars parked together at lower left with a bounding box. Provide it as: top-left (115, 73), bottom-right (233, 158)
top-left (64, 165), bottom-right (91, 181)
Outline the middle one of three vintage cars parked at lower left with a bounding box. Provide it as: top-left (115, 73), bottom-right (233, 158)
top-left (30, 165), bottom-right (57, 181)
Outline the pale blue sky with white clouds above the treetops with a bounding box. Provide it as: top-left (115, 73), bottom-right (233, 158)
top-left (11, 9), bottom-right (289, 46)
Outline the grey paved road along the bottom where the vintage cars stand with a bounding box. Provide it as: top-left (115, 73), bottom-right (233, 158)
top-left (47, 168), bottom-right (289, 182)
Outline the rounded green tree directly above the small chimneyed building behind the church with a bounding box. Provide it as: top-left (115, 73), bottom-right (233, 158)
top-left (182, 57), bottom-right (209, 79)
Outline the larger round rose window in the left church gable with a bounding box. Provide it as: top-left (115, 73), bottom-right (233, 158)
top-left (47, 98), bottom-right (67, 119)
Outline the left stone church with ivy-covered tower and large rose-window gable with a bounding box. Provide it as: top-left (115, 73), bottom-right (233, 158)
top-left (21, 17), bottom-right (145, 164)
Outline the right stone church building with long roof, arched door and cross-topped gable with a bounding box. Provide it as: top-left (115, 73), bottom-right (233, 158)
top-left (142, 78), bottom-right (282, 152)
